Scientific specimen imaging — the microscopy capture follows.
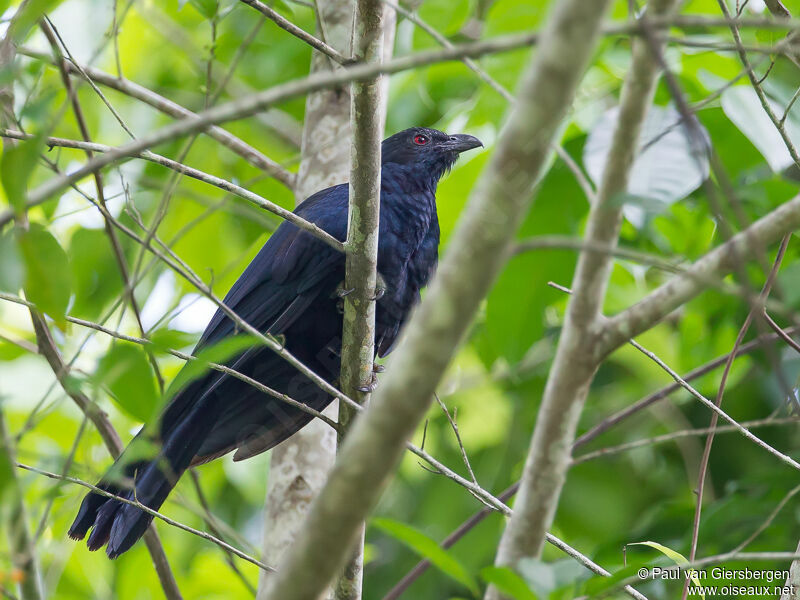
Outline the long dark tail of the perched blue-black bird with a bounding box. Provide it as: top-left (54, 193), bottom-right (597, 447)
top-left (69, 394), bottom-right (214, 558)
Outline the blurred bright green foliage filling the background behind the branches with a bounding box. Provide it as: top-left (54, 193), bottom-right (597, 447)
top-left (0, 0), bottom-right (800, 600)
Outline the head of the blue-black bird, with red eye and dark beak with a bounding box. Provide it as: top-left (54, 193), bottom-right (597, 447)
top-left (381, 127), bottom-right (483, 182)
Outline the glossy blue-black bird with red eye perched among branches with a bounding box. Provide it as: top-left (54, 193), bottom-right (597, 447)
top-left (69, 127), bottom-right (482, 558)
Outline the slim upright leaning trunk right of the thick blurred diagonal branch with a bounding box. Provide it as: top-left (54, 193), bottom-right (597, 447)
top-left (485, 0), bottom-right (674, 600)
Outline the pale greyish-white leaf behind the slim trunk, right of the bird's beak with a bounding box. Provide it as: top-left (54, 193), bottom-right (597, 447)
top-left (583, 106), bottom-right (709, 227)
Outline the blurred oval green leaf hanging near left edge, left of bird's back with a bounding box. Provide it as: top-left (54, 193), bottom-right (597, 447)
top-left (18, 223), bottom-right (72, 322)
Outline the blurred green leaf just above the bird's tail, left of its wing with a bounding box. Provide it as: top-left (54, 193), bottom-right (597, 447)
top-left (94, 343), bottom-right (159, 422)
